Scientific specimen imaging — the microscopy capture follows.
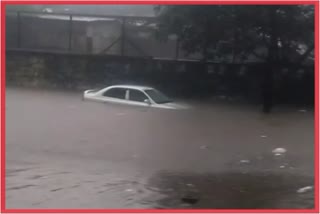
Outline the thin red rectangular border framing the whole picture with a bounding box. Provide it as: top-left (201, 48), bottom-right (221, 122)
top-left (1, 0), bottom-right (320, 213)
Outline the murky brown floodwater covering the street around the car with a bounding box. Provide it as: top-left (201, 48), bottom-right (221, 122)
top-left (6, 88), bottom-right (314, 209)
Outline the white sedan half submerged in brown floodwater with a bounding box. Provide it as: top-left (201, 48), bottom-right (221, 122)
top-left (83, 85), bottom-right (189, 109)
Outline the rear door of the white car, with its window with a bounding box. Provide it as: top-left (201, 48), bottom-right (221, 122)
top-left (101, 88), bottom-right (128, 104)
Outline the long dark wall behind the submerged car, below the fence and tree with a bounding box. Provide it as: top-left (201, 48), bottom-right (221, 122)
top-left (6, 51), bottom-right (314, 103)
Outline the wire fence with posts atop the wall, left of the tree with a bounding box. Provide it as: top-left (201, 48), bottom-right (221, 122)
top-left (6, 12), bottom-right (196, 59)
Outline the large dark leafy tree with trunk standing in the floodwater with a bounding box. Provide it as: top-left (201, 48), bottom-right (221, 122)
top-left (155, 5), bottom-right (314, 113)
